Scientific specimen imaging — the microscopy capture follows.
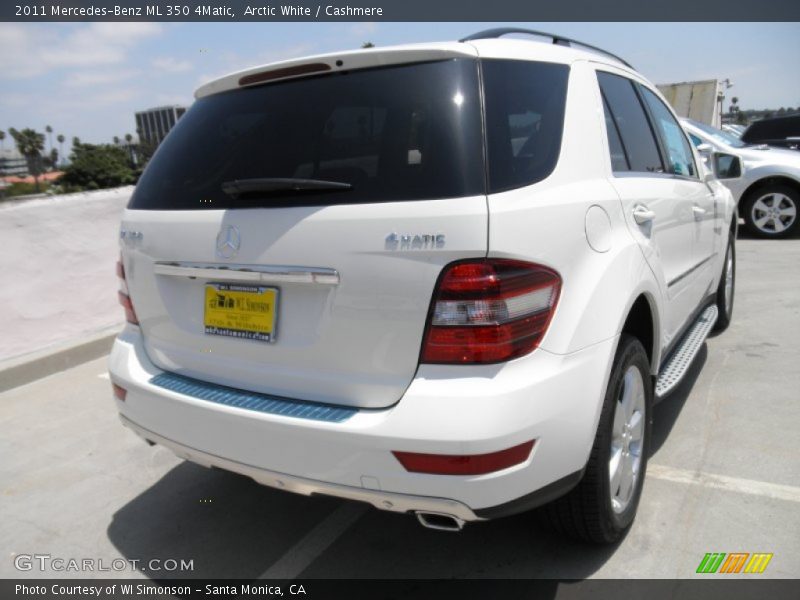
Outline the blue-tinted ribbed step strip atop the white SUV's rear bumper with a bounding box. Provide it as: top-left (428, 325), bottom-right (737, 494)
top-left (150, 372), bottom-right (358, 423)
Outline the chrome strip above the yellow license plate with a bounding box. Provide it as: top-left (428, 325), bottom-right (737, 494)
top-left (153, 262), bottom-right (339, 285)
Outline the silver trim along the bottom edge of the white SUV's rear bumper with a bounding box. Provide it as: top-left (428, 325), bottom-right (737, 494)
top-left (119, 418), bottom-right (486, 521)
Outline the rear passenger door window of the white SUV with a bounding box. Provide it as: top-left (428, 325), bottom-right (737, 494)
top-left (597, 71), bottom-right (664, 173)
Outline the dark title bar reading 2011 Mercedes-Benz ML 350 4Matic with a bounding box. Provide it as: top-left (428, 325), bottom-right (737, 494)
top-left (0, 0), bottom-right (800, 22)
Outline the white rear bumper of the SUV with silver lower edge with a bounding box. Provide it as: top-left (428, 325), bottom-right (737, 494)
top-left (109, 326), bottom-right (617, 521)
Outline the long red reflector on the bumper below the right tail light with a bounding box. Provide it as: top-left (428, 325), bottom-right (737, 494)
top-left (392, 440), bottom-right (533, 475)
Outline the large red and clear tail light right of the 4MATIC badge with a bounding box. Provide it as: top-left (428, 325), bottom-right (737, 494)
top-left (421, 259), bottom-right (561, 364)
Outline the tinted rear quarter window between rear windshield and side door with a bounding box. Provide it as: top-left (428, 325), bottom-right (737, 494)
top-left (483, 60), bottom-right (569, 192)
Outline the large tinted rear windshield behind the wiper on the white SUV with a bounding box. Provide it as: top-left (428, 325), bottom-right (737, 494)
top-left (130, 59), bottom-right (485, 210)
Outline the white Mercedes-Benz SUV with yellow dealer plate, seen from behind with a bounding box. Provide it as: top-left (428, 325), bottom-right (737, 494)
top-left (110, 29), bottom-right (737, 542)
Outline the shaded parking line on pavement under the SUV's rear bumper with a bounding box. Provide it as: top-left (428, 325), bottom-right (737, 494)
top-left (259, 502), bottom-right (367, 579)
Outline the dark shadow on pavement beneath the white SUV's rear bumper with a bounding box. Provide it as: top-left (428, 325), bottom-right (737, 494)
top-left (107, 458), bottom-right (616, 580)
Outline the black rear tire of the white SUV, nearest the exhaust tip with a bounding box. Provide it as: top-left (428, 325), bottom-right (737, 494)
top-left (542, 334), bottom-right (653, 544)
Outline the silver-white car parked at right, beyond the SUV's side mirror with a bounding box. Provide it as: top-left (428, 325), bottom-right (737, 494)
top-left (682, 119), bottom-right (800, 238)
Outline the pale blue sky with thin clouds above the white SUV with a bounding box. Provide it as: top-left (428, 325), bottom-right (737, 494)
top-left (0, 23), bottom-right (800, 155)
